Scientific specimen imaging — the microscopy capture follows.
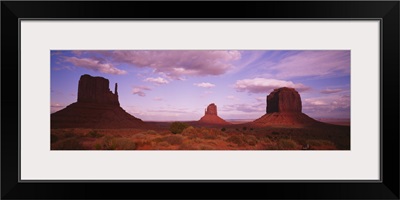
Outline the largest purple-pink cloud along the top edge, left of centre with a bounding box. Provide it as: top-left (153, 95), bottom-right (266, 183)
top-left (86, 50), bottom-right (241, 79)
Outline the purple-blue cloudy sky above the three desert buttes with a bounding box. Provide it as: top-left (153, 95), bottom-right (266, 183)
top-left (50, 50), bottom-right (350, 121)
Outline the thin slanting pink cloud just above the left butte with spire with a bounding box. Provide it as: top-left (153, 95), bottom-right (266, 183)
top-left (64, 57), bottom-right (126, 75)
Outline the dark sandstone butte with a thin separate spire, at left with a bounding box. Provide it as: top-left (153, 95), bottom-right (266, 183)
top-left (51, 74), bottom-right (145, 128)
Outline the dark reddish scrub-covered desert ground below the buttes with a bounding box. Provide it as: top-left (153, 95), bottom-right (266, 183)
top-left (51, 122), bottom-right (350, 150)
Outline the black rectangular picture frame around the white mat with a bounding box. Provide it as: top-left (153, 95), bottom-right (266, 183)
top-left (1, 1), bottom-right (400, 199)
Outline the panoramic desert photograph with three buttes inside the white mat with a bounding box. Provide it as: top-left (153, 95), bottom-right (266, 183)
top-left (50, 50), bottom-right (351, 151)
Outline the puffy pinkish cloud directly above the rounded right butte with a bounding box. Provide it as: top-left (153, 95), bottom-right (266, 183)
top-left (234, 78), bottom-right (309, 93)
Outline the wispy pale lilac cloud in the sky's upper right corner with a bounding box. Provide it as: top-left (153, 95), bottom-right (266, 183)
top-left (269, 50), bottom-right (350, 79)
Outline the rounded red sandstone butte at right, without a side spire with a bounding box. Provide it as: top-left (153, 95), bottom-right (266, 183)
top-left (252, 87), bottom-right (324, 126)
